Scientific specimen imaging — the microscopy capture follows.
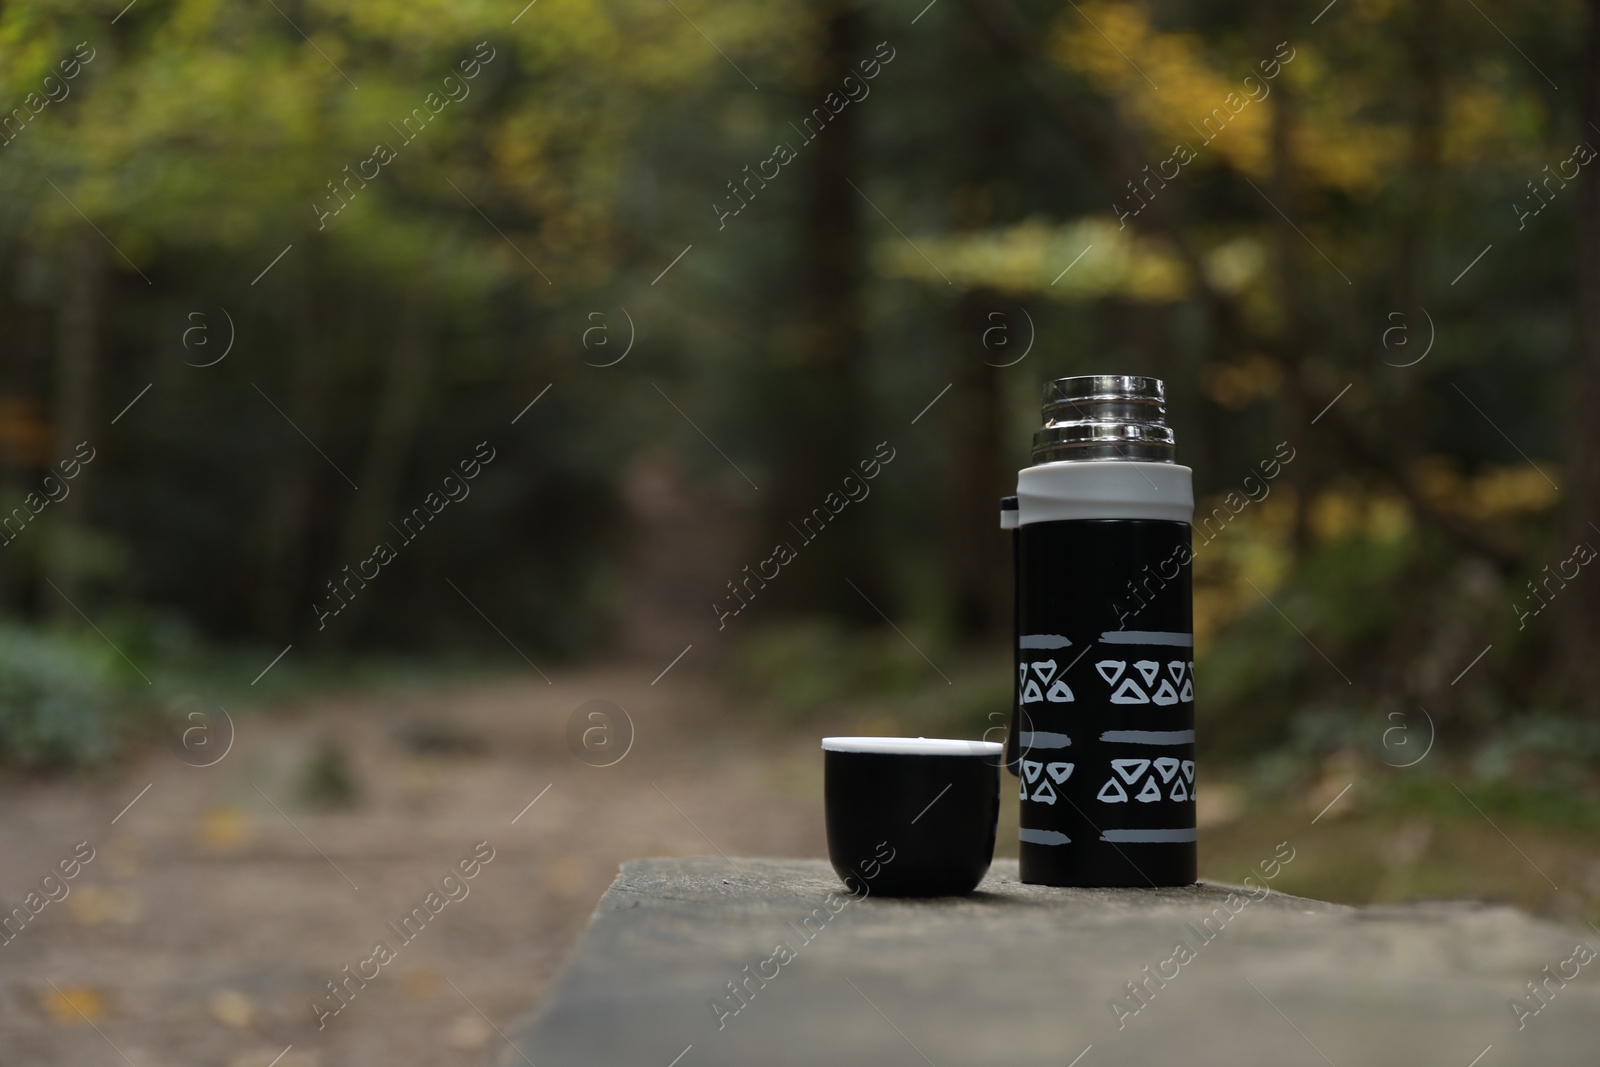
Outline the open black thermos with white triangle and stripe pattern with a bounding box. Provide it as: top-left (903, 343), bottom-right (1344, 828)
top-left (1000, 374), bottom-right (1195, 886)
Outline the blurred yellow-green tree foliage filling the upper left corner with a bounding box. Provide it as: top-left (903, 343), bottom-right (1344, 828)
top-left (0, 0), bottom-right (768, 275)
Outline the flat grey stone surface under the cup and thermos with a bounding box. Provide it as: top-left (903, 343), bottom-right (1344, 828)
top-left (502, 857), bottom-right (1600, 1067)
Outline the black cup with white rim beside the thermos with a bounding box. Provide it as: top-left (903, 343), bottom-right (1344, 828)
top-left (822, 737), bottom-right (1003, 896)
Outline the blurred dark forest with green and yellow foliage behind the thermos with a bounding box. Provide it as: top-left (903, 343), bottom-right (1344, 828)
top-left (0, 0), bottom-right (1600, 897)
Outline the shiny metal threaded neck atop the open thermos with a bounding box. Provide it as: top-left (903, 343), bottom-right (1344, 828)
top-left (1034, 374), bottom-right (1178, 464)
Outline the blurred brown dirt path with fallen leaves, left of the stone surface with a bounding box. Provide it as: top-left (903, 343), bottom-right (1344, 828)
top-left (0, 669), bottom-right (824, 1067)
